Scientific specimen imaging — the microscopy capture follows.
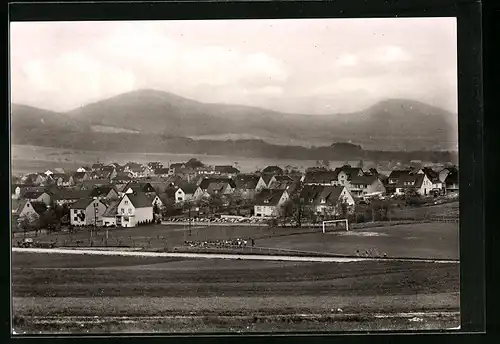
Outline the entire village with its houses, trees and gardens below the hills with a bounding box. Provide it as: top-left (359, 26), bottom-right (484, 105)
top-left (11, 158), bottom-right (459, 239)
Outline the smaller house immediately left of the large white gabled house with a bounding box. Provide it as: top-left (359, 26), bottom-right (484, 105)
top-left (69, 198), bottom-right (107, 226)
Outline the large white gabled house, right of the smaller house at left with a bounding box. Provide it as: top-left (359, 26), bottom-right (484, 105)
top-left (116, 193), bottom-right (153, 227)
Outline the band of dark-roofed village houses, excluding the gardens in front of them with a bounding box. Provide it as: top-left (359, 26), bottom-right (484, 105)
top-left (12, 162), bottom-right (458, 227)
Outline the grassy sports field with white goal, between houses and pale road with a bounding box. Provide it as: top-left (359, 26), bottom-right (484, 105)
top-left (23, 222), bottom-right (459, 259)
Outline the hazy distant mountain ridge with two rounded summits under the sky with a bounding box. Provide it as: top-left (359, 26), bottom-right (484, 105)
top-left (12, 89), bottom-right (458, 150)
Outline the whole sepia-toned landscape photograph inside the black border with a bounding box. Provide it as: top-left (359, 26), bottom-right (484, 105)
top-left (9, 17), bottom-right (460, 335)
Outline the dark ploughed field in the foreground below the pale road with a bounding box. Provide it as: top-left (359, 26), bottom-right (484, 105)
top-left (12, 252), bottom-right (459, 332)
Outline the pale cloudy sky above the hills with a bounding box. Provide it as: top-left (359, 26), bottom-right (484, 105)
top-left (10, 18), bottom-right (458, 114)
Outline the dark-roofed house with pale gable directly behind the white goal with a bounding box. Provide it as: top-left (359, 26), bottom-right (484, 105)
top-left (300, 185), bottom-right (355, 215)
